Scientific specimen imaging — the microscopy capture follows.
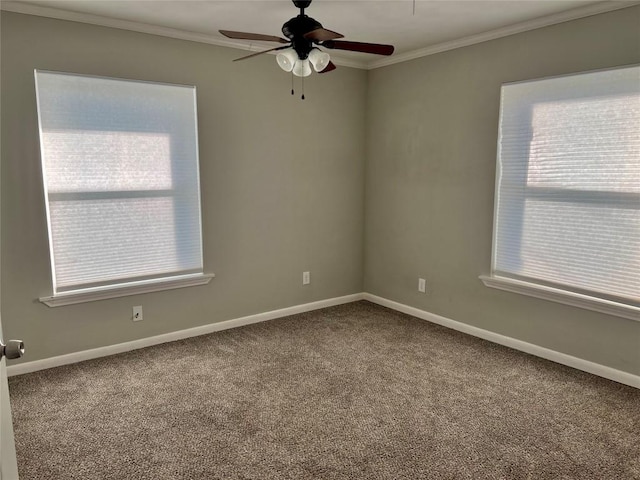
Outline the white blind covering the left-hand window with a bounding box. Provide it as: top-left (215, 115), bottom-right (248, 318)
top-left (35, 71), bottom-right (202, 294)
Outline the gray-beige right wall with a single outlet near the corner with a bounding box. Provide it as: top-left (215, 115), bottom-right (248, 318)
top-left (365, 7), bottom-right (640, 374)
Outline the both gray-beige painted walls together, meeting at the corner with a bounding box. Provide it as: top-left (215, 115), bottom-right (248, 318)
top-left (1, 7), bottom-right (640, 374)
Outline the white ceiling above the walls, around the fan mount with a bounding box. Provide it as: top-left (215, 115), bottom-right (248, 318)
top-left (1, 0), bottom-right (638, 68)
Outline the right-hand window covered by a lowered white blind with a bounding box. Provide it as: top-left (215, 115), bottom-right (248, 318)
top-left (482, 62), bottom-right (640, 320)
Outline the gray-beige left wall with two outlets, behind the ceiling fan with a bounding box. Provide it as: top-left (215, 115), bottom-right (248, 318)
top-left (1, 12), bottom-right (367, 361)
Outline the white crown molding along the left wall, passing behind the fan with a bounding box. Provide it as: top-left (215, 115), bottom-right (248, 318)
top-left (0, 1), bottom-right (367, 69)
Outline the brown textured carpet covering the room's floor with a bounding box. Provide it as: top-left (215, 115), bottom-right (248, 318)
top-left (10, 302), bottom-right (640, 480)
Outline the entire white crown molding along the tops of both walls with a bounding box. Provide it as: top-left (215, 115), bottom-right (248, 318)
top-left (0, 0), bottom-right (640, 70)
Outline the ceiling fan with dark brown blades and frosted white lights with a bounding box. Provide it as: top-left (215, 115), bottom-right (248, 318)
top-left (220, 0), bottom-right (393, 77)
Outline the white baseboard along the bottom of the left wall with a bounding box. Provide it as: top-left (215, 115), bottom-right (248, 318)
top-left (7, 293), bottom-right (364, 376)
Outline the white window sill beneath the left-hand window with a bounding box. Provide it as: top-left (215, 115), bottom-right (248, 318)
top-left (39, 273), bottom-right (215, 307)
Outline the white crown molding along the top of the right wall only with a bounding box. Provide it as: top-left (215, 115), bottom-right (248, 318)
top-left (366, 0), bottom-right (640, 70)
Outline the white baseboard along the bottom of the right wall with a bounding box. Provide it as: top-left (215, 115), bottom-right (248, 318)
top-left (363, 293), bottom-right (640, 388)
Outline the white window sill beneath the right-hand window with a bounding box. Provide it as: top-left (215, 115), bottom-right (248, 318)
top-left (480, 275), bottom-right (640, 321)
